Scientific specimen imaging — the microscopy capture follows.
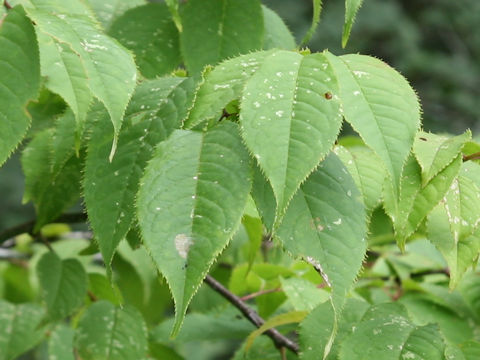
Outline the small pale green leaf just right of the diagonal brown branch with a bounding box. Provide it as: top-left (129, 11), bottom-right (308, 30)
top-left (280, 277), bottom-right (330, 311)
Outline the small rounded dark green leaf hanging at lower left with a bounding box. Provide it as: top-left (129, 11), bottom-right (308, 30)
top-left (37, 251), bottom-right (87, 320)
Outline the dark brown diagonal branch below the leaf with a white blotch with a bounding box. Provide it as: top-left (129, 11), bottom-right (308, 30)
top-left (205, 275), bottom-right (300, 354)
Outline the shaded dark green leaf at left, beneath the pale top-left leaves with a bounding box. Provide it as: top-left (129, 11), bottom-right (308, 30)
top-left (21, 119), bottom-right (83, 232)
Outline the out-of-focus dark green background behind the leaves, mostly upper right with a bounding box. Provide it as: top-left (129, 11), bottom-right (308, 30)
top-left (0, 0), bottom-right (480, 230)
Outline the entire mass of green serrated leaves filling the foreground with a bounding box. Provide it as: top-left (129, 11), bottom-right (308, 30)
top-left (0, 0), bottom-right (480, 360)
